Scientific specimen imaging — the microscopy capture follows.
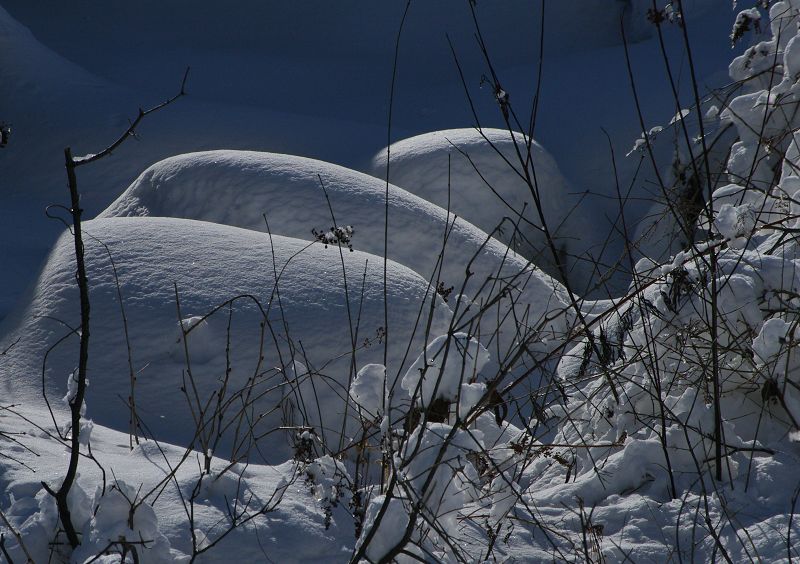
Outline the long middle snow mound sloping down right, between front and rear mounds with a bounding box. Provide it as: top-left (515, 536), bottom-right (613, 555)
top-left (99, 151), bottom-right (569, 346)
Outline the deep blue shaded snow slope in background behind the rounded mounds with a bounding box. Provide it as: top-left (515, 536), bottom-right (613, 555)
top-left (0, 0), bottom-right (730, 316)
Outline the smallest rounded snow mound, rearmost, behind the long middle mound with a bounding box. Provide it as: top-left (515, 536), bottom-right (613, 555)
top-left (372, 128), bottom-right (593, 290)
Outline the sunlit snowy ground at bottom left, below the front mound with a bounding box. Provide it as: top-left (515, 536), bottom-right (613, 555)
top-left (3, 411), bottom-right (353, 562)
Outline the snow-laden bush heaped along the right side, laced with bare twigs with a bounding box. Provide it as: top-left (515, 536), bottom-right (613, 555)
top-left (352, 2), bottom-right (800, 561)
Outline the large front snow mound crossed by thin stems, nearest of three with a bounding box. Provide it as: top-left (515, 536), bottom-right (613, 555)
top-left (2, 218), bottom-right (449, 462)
